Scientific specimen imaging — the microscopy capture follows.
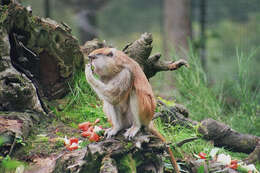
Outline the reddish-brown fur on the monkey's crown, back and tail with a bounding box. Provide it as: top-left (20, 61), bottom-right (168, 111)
top-left (87, 48), bottom-right (179, 173)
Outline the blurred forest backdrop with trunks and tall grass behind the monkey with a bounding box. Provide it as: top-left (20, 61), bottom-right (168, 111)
top-left (21, 0), bottom-right (260, 135)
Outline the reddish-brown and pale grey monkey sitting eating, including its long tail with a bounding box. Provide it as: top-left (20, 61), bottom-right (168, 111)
top-left (85, 48), bottom-right (179, 172)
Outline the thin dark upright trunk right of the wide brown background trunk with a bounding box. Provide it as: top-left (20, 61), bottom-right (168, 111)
top-left (200, 0), bottom-right (207, 71)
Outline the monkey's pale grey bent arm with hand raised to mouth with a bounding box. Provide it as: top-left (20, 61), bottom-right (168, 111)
top-left (85, 65), bottom-right (132, 105)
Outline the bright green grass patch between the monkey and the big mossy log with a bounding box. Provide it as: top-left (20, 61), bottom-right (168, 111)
top-left (55, 72), bottom-right (107, 128)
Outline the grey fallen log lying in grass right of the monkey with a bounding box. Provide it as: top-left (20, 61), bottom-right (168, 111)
top-left (159, 101), bottom-right (260, 163)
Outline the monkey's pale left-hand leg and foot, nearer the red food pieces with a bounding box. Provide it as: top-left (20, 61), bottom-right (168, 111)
top-left (103, 101), bottom-right (123, 138)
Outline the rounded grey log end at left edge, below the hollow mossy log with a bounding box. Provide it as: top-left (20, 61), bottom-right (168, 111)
top-left (0, 56), bottom-right (43, 112)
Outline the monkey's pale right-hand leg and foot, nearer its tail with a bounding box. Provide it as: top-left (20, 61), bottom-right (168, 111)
top-left (124, 91), bottom-right (141, 139)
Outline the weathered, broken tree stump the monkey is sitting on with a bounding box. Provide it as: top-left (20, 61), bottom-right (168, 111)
top-left (26, 133), bottom-right (165, 173)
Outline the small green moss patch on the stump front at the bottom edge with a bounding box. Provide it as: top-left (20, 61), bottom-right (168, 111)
top-left (117, 153), bottom-right (136, 173)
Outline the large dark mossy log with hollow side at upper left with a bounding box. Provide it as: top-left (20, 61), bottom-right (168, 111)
top-left (0, 3), bottom-right (83, 100)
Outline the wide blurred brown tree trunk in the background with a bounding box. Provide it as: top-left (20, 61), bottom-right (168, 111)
top-left (164, 0), bottom-right (191, 57)
